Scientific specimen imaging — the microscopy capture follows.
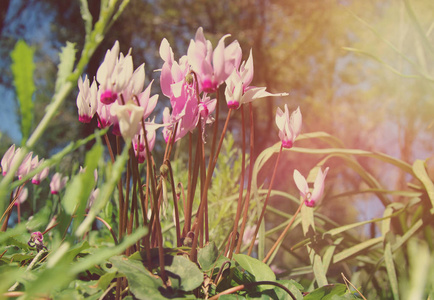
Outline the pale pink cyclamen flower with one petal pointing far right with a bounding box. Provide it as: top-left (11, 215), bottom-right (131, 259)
top-left (225, 50), bottom-right (288, 109)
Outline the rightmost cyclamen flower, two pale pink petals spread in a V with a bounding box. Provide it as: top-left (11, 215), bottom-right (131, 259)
top-left (294, 168), bottom-right (329, 207)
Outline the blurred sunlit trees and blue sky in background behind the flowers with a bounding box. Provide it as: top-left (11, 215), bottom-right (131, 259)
top-left (0, 0), bottom-right (434, 268)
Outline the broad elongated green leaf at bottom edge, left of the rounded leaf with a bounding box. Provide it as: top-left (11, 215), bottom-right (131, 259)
top-left (110, 256), bottom-right (166, 300)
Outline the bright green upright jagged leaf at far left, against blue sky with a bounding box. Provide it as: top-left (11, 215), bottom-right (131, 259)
top-left (11, 40), bottom-right (35, 145)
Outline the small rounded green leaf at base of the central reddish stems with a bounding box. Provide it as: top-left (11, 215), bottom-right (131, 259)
top-left (166, 256), bottom-right (203, 292)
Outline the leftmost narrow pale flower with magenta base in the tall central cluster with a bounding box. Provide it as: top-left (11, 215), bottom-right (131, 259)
top-left (77, 75), bottom-right (98, 123)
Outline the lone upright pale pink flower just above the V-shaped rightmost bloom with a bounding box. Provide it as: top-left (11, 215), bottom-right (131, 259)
top-left (276, 104), bottom-right (302, 148)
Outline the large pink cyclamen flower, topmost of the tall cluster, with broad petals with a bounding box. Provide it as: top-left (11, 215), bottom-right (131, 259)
top-left (187, 27), bottom-right (242, 93)
